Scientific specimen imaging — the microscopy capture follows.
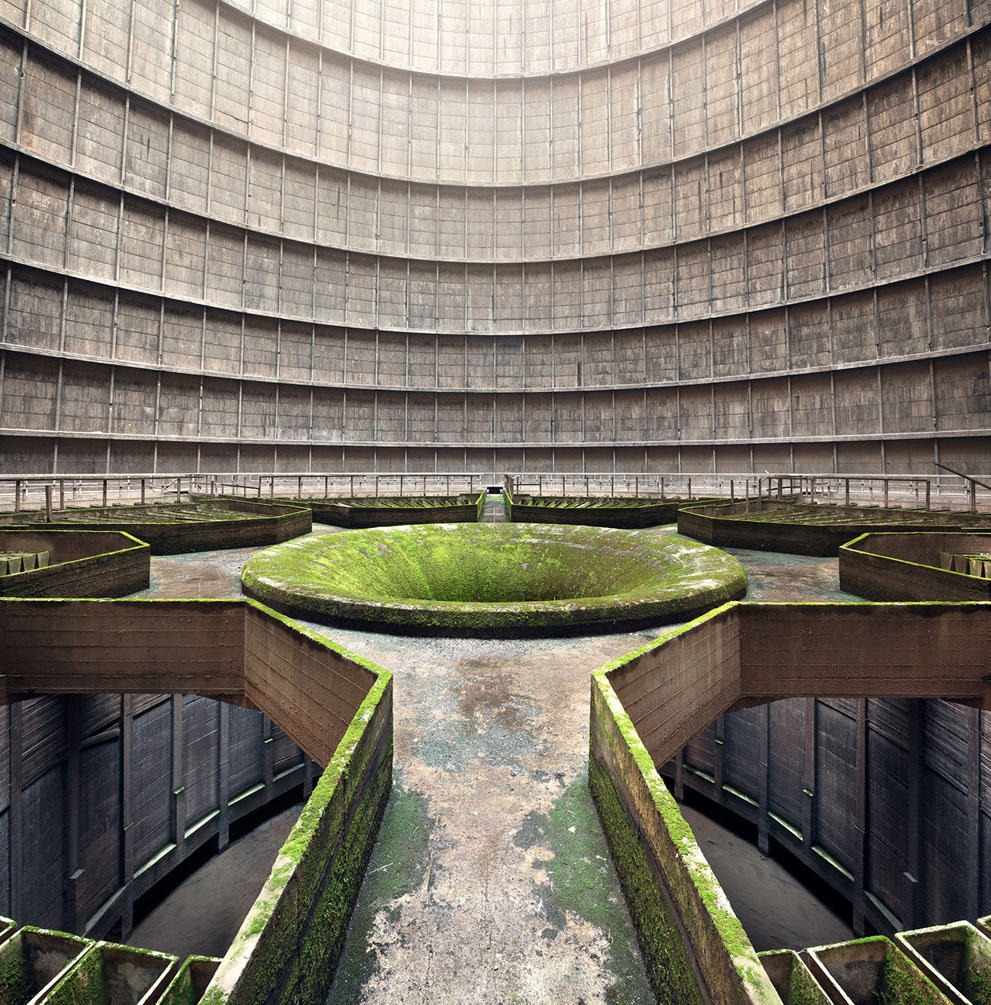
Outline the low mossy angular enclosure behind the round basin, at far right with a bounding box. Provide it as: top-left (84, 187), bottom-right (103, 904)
top-left (677, 499), bottom-right (991, 557)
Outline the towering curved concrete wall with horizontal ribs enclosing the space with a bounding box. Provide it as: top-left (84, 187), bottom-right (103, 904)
top-left (0, 0), bottom-right (991, 471)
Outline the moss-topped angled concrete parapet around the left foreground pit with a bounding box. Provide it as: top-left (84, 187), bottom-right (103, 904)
top-left (0, 600), bottom-right (392, 1005)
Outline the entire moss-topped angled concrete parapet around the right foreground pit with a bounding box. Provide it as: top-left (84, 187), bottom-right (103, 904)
top-left (589, 603), bottom-right (991, 1005)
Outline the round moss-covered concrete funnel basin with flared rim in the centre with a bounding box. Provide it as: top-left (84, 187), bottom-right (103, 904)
top-left (241, 524), bottom-right (747, 637)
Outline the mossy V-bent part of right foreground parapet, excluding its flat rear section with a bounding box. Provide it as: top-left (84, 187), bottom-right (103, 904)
top-left (589, 608), bottom-right (778, 1005)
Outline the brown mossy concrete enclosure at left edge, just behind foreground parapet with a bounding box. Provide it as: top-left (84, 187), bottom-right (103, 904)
top-left (0, 529), bottom-right (151, 597)
